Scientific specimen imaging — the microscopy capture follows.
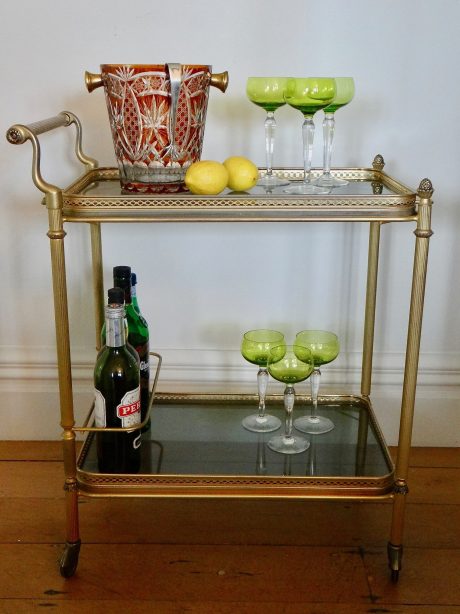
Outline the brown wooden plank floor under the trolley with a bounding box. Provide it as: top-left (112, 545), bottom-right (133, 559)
top-left (0, 442), bottom-right (460, 614)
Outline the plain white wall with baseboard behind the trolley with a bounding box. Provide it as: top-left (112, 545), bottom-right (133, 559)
top-left (0, 0), bottom-right (460, 445)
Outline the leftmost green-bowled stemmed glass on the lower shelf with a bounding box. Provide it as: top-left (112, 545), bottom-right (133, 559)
top-left (241, 328), bottom-right (286, 433)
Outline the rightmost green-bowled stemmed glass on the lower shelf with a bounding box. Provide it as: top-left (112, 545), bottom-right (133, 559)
top-left (294, 330), bottom-right (340, 435)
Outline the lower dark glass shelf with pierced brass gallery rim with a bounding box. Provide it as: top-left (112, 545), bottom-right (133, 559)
top-left (77, 393), bottom-right (394, 498)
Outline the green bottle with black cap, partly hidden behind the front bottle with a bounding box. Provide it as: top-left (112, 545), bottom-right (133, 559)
top-left (113, 266), bottom-right (150, 430)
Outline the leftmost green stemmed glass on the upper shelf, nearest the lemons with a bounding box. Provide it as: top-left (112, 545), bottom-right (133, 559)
top-left (246, 77), bottom-right (289, 188)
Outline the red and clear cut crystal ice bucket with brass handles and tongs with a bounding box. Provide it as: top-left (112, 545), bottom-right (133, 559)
top-left (86, 64), bottom-right (228, 193)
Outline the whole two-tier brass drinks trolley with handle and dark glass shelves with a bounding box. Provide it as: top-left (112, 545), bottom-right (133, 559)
top-left (7, 111), bottom-right (433, 581)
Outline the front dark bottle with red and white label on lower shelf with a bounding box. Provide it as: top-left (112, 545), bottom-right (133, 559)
top-left (94, 305), bottom-right (141, 473)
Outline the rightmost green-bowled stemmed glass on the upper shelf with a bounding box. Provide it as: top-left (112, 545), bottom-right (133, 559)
top-left (313, 77), bottom-right (355, 188)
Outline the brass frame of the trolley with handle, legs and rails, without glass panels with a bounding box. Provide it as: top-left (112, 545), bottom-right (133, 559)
top-left (7, 111), bottom-right (433, 581)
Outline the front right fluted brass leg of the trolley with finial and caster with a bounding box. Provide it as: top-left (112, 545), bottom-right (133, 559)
top-left (388, 179), bottom-right (433, 582)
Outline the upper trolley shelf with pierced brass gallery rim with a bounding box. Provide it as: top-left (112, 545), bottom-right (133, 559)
top-left (63, 168), bottom-right (417, 222)
